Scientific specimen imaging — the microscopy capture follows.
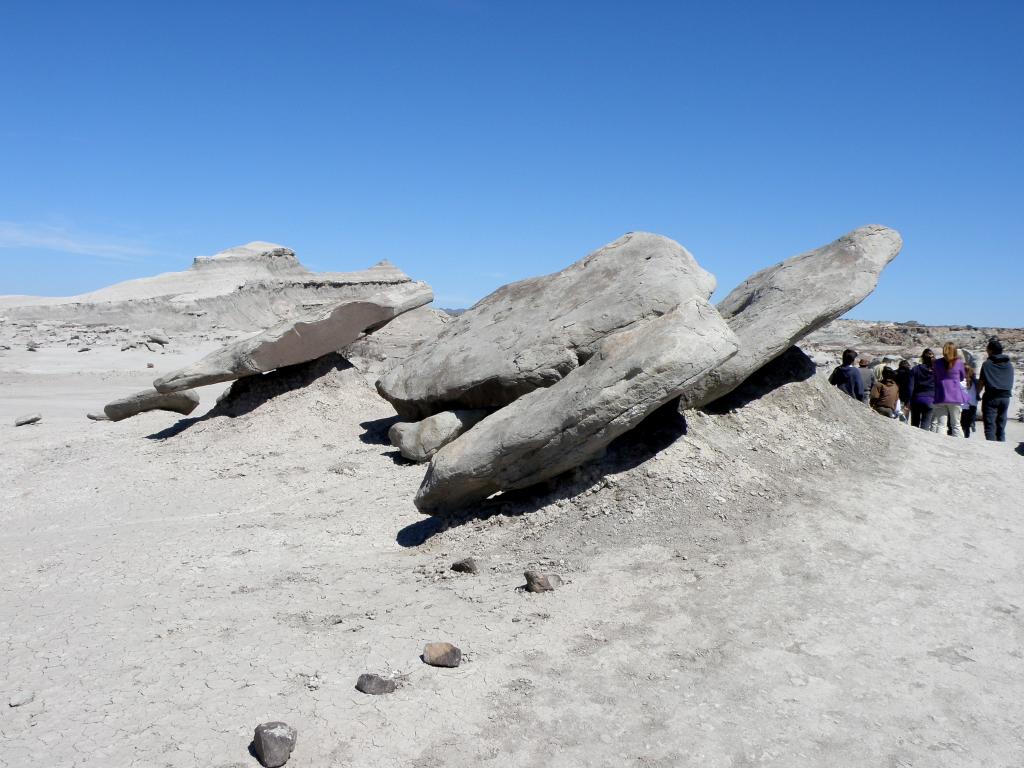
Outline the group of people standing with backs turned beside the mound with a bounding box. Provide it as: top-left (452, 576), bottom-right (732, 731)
top-left (828, 338), bottom-right (1014, 441)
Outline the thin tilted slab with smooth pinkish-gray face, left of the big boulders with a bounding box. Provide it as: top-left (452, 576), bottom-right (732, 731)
top-left (154, 283), bottom-right (434, 392)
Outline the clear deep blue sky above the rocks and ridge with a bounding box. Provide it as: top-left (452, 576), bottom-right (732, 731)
top-left (0, 0), bottom-right (1024, 326)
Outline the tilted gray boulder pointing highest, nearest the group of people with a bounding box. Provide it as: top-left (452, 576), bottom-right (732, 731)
top-left (680, 224), bottom-right (903, 409)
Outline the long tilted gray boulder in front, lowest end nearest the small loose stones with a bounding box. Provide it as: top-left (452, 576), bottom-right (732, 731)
top-left (416, 298), bottom-right (737, 515)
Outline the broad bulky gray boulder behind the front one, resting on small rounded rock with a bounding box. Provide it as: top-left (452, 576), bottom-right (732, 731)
top-left (377, 232), bottom-right (715, 421)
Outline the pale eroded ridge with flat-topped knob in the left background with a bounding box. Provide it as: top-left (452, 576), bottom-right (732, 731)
top-left (0, 242), bottom-right (412, 333)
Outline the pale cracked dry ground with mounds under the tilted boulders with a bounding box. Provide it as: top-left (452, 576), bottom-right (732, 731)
top-left (0, 350), bottom-right (1024, 768)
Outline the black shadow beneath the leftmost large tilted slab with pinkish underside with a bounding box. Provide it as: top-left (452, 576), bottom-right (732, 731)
top-left (146, 352), bottom-right (354, 440)
